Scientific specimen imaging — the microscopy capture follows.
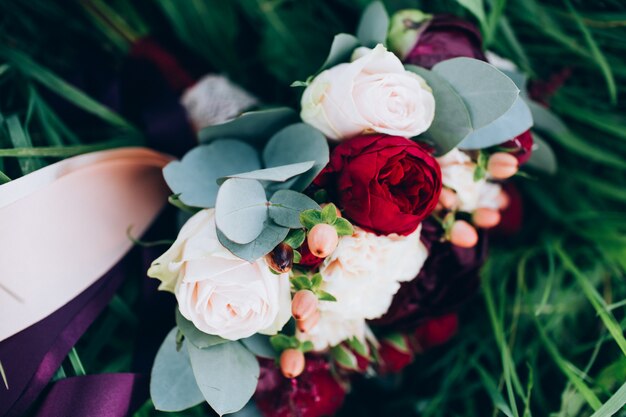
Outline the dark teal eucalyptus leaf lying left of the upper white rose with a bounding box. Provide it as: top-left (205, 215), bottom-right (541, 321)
top-left (198, 107), bottom-right (298, 145)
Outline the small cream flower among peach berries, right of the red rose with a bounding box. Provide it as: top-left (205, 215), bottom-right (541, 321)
top-left (437, 148), bottom-right (501, 213)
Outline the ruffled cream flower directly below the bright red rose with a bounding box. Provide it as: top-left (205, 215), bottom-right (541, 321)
top-left (299, 227), bottom-right (428, 350)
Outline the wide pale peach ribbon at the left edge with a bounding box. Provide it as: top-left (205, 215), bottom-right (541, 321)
top-left (0, 148), bottom-right (170, 342)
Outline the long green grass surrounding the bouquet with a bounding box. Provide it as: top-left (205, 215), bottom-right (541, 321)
top-left (0, 0), bottom-right (626, 417)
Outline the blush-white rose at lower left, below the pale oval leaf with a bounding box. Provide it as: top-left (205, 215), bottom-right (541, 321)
top-left (148, 209), bottom-right (291, 340)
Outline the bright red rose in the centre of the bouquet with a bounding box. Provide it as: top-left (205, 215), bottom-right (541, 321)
top-left (316, 135), bottom-right (441, 235)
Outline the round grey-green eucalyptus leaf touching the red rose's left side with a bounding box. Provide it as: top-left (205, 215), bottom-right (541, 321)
top-left (263, 123), bottom-right (329, 191)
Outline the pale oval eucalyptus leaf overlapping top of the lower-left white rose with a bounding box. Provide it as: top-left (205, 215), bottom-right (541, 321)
top-left (215, 178), bottom-right (267, 244)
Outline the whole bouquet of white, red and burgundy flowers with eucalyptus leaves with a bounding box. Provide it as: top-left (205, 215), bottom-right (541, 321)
top-left (148, 3), bottom-right (553, 417)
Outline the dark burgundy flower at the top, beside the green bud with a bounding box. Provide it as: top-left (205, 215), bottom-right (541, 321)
top-left (404, 14), bottom-right (487, 69)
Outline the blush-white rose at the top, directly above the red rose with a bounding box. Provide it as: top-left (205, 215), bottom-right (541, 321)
top-left (300, 44), bottom-right (435, 139)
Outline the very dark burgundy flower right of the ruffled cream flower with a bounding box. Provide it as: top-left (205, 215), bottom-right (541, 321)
top-left (372, 219), bottom-right (487, 330)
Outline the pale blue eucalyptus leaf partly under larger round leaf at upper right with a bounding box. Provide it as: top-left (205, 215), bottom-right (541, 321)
top-left (458, 97), bottom-right (533, 149)
